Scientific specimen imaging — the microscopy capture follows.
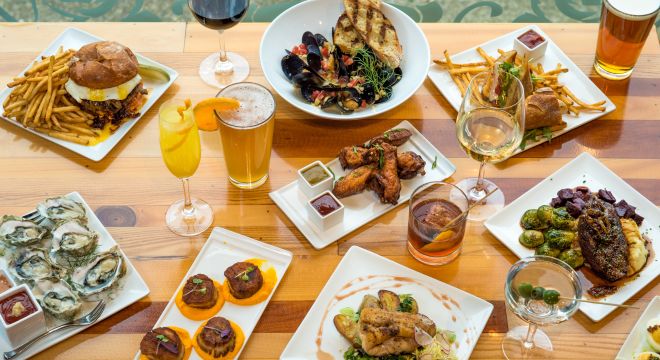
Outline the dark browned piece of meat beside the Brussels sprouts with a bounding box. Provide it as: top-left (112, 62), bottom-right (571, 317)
top-left (578, 197), bottom-right (628, 281)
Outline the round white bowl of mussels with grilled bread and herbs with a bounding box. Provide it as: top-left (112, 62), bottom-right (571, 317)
top-left (260, 0), bottom-right (430, 120)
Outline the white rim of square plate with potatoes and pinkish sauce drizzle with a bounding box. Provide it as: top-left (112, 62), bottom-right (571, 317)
top-left (280, 245), bottom-right (495, 359)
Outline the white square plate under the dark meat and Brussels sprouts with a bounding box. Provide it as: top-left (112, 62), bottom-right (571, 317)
top-left (484, 152), bottom-right (660, 321)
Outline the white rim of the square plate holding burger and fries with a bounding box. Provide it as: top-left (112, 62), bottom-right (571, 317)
top-left (0, 26), bottom-right (179, 162)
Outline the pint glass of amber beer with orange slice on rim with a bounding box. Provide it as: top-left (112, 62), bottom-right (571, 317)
top-left (215, 82), bottom-right (275, 189)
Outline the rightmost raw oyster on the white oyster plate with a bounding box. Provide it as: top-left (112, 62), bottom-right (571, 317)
top-left (71, 246), bottom-right (126, 297)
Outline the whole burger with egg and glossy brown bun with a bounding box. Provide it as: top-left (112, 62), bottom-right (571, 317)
top-left (64, 41), bottom-right (147, 129)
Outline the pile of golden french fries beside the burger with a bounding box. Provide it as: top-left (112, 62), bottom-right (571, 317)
top-left (2, 47), bottom-right (101, 145)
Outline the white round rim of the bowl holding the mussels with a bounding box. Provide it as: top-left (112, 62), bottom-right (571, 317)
top-left (259, 0), bottom-right (431, 121)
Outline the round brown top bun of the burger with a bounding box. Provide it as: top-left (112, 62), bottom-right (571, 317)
top-left (69, 41), bottom-right (138, 89)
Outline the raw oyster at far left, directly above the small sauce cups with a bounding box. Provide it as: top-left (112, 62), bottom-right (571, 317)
top-left (9, 248), bottom-right (66, 281)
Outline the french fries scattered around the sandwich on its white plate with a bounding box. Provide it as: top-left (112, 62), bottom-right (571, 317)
top-left (434, 47), bottom-right (605, 116)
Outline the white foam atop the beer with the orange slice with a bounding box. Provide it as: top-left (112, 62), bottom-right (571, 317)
top-left (219, 83), bottom-right (275, 127)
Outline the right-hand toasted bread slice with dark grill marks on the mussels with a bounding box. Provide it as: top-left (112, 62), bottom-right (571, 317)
top-left (344, 0), bottom-right (403, 69)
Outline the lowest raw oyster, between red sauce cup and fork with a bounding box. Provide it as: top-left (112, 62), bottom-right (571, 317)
top-left (32, 277), bottom-right (82, 320)
